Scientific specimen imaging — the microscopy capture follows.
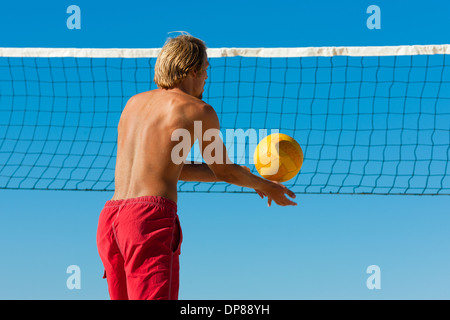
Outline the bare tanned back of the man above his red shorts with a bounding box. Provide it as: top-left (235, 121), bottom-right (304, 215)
top-left (113, 89), bottom-right (205, 202)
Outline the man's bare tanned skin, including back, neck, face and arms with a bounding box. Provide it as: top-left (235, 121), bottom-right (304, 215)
top-left (112, 59), bottom-right (297, 206)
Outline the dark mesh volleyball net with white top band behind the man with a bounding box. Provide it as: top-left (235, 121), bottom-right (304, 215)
top-left (0, 45), bottom-right (450, 195)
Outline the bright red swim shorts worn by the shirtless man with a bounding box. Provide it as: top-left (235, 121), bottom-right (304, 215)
top-left (97, 196), bottom-right (182, 300)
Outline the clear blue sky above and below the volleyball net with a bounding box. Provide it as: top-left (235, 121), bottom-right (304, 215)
top-left (0, 0), bottom-right (450, 299)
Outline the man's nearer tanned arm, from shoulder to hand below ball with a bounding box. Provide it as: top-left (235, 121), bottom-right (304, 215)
top-left (196, 104), bottom-right (297, 206)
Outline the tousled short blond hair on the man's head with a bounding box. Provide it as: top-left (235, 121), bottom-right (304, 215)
top-left (154, 34), bottom-right (206, 89)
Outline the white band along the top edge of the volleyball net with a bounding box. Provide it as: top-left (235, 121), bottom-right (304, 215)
top-left (0, 44), bottom-right (450, 58)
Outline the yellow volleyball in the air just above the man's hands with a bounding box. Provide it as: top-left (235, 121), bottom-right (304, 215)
top-left (253, 133), bottom-right (303, 182)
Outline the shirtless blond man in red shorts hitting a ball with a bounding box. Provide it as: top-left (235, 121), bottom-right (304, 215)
top-left (97, 35), bottom-right (296, 300)
